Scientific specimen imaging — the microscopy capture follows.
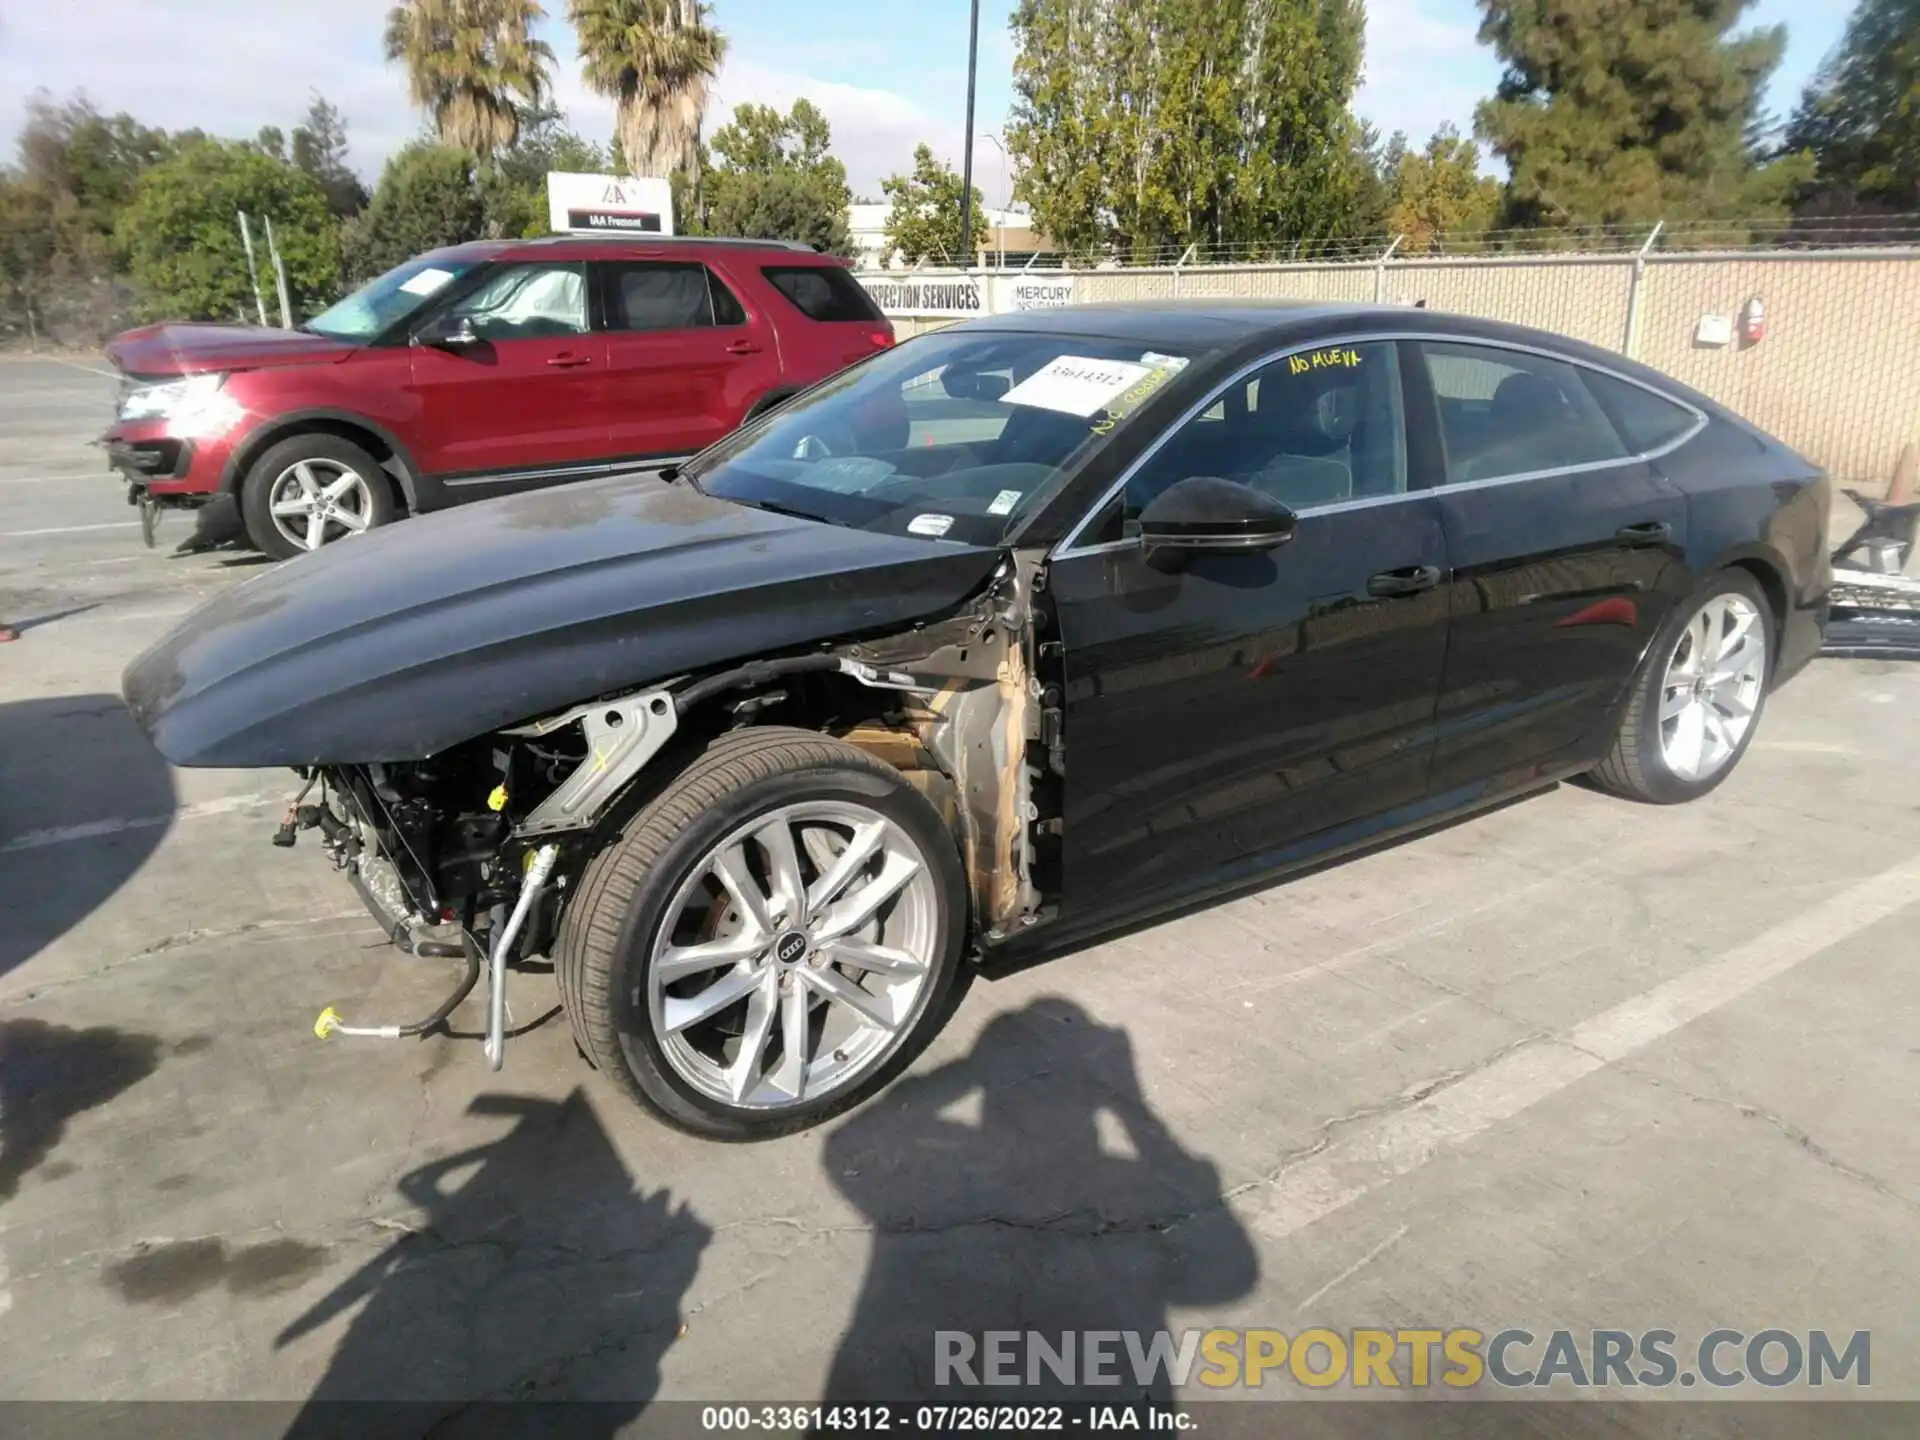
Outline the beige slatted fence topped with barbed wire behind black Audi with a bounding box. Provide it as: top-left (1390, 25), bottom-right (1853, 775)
top-left (858, 231), bottom-right (1920, 486)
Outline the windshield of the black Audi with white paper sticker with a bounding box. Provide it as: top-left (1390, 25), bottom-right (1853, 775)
top-left (689, 330), bottom-right (1198, 545)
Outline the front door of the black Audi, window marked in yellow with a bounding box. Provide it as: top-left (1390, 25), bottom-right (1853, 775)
top-left (1048, 342), bottom-right (1448, 914)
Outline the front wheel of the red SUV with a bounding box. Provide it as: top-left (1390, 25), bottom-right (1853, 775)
top-left (240, 434), bottom-right (394, 561)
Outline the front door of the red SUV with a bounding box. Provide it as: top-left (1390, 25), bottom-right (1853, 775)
top-left (405, 261), bottom-right (607, 493)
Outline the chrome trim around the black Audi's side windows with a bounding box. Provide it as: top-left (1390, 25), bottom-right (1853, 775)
top-left (1048, 330), bottom-right (1707, 561)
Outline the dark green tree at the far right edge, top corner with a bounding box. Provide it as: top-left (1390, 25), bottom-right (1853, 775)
top-left (1786, 0), bottom-right (1920, 209)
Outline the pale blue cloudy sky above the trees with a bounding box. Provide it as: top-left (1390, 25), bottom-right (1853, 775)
top-left (0, 0), bottom-right (1851, 204)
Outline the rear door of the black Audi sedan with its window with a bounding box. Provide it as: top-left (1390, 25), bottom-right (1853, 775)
top-left (1405, 340), bottom-right (1690, 793)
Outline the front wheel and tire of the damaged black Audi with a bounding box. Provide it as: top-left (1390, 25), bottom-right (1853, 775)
top-left (555, 728), bottom-right (966, 1140)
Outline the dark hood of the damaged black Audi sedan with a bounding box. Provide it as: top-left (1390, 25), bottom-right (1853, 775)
top-left (123, 476), bottom-right (1000, 766)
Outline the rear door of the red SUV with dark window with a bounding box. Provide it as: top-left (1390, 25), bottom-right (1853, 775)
top-left (593, 259), bottom-right (780, 461)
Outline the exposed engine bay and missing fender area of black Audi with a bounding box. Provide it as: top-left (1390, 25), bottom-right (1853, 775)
top-left (291, 555), bottom-right (1064, 1068)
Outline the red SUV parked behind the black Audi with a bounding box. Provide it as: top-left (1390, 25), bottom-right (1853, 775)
top-left (106, 236), bottom-right (893, 557)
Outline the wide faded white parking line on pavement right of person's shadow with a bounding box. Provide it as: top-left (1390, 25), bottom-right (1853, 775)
top-left (1236, 856), bottom-right (1920, 1238)
